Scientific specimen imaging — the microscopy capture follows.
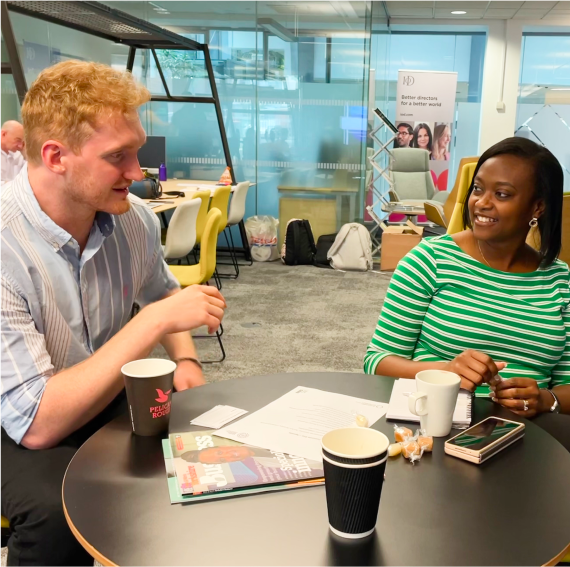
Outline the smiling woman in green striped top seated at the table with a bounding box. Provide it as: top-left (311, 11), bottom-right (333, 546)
top-left (364, 138), bottom-right (570, 417)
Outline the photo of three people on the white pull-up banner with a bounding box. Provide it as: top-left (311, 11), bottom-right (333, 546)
top-left (394, 121), bottom-right (451, 191)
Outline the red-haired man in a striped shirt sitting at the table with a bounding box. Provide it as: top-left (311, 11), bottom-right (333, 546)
top-left (0, 61), bottom-right (226, 567)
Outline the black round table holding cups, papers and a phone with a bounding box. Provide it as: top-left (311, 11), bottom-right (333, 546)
top-left (63, 373), bottom-right (570, 567)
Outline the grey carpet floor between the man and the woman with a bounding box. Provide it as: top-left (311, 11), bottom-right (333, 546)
top-left (0, 262), bottom-right (391, 567)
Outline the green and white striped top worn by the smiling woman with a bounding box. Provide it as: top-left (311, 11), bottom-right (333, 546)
top-left (364, 235), bottom-right (570, 396)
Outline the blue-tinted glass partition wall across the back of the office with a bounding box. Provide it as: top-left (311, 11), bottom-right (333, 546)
top-left (0, 0), bottom-right (486, 241)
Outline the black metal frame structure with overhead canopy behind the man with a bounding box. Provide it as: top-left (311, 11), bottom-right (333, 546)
top-left (0, 0), bottom-right (250, 260)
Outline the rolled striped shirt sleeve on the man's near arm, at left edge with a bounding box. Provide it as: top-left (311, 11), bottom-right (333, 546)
top-left (0, 271), bottom-right (53, 443)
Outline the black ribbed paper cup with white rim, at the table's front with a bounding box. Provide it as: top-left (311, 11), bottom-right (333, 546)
top-left (322, 427), bottom-right (390, 539)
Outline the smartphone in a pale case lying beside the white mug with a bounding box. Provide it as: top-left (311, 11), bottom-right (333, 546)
top-left (444, 417), bottom-right (524, 465)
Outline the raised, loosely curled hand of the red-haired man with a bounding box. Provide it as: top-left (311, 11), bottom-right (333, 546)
top-left (158, 285), bottom-right (226, 334)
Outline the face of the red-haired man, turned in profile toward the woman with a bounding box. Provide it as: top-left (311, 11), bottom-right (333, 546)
top-left (61, 114), bottom-right (146, 215)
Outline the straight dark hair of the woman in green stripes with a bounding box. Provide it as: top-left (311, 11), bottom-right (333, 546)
top-left (463, 137), bottom-right (564, 266)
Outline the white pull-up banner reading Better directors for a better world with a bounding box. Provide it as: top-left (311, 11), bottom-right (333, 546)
top-left (394, 69), bottom-right (457, 191)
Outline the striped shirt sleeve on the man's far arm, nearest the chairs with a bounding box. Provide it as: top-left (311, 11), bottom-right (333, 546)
top-left (136, 206), bottom-right (180, 307)
